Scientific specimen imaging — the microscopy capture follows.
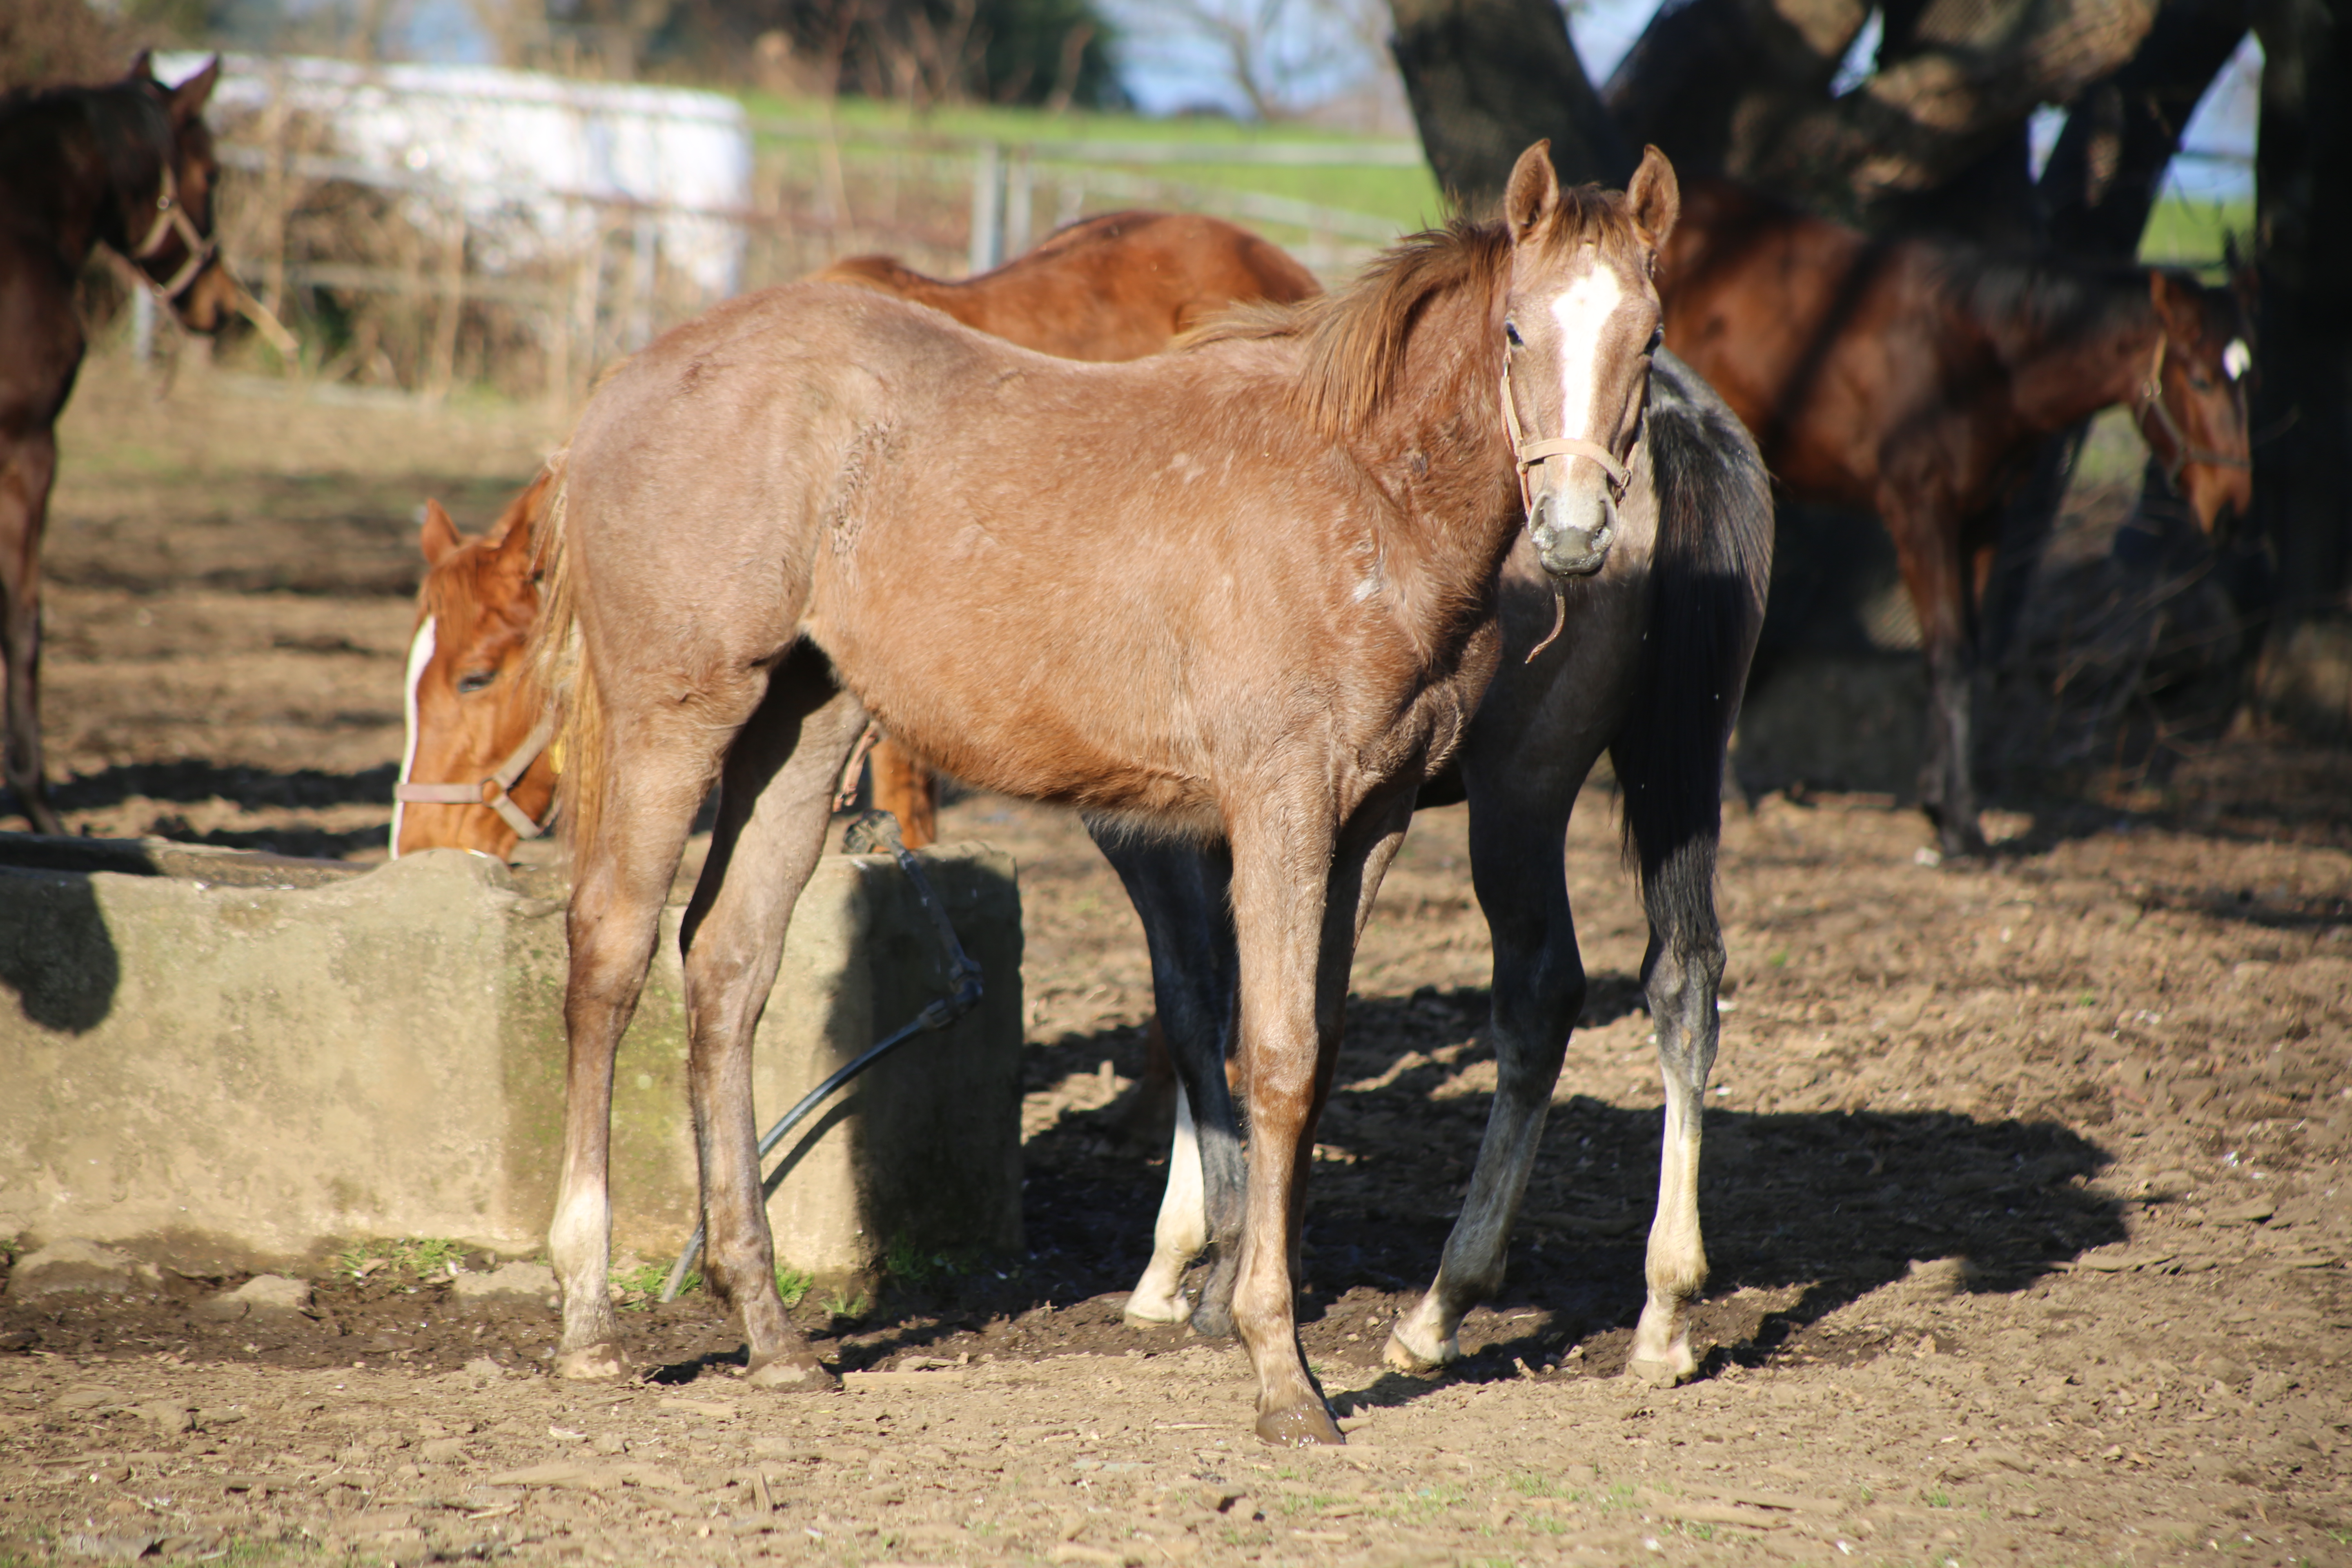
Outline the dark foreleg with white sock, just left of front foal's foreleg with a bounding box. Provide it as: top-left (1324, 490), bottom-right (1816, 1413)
top-left (1087, 820), bottom-right (1247, 1335)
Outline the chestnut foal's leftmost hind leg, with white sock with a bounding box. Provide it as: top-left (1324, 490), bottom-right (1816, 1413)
top-left (548, 719), bottom-right (713, 1378)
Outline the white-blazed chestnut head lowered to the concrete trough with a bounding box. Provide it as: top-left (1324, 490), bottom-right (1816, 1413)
top-left (393, 472), bottom-right (555, 860)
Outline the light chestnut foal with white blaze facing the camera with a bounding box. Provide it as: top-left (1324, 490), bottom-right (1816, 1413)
top-left (539, 143), bottom-right (1675, 1443)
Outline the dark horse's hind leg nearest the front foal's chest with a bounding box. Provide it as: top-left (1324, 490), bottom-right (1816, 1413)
top-left (1385, 775), bottom-right (1585, 1373)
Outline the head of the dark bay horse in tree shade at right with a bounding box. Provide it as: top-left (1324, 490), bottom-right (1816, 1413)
top-left (2131, 273), bottom-right (2253, 534)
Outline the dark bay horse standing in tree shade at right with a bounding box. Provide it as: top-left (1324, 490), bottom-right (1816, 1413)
top-left (1658, 181), bottom-right (2251, 856)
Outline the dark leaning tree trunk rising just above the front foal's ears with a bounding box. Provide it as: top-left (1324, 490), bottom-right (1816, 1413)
top-left (1388, 0), bottom-right (1632, 216)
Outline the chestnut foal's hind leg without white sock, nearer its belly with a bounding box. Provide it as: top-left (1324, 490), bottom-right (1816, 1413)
top-left (680, 649), bottom-right (866, 1387)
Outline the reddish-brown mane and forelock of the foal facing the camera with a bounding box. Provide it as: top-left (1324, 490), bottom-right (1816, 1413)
top-left (1174, 186), bottom-right (1632, 435)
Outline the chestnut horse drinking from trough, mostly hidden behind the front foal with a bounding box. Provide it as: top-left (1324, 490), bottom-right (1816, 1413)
top-left (393, 212), bottom-right (1322, 858)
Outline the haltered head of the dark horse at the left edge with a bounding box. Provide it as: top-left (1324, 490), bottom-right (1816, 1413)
top-left (118, 54), bottom-right (238, 332)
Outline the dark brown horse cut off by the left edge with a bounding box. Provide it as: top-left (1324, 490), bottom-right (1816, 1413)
top-left (0, 54), bottom-right (238, 832)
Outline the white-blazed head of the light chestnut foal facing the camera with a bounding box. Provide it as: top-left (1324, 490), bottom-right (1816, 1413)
top-left (1498, 141), bottom-right (1679, 576)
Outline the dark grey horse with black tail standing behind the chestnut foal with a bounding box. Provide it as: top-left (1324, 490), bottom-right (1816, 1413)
top-left (1115, 350), bottom-right (1771, 1382)
